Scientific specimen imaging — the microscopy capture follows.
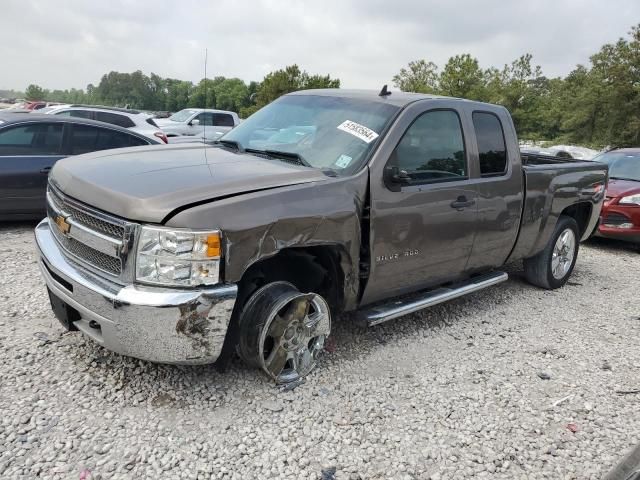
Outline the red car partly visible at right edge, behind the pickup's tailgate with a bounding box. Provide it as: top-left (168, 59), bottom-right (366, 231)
top-left (594, 148), bottom-right (640, 243)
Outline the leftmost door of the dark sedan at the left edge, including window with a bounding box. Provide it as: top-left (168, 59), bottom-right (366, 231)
top-left (0, 122), bottom-right (64, 216)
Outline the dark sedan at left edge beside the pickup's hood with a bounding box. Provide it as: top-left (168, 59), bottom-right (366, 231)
top-left (0, 112), bottom-right (160, 220)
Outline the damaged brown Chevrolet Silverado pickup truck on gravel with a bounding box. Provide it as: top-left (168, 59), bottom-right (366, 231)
top-left (35, 88), bottom-right (607, 383)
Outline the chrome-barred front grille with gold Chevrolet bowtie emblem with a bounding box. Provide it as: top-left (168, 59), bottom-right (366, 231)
top-left (47, 185), bottom-right (136, 283)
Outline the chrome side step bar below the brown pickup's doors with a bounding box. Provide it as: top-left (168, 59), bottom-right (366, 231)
top-left (361, 272), bottom-right (509, 327)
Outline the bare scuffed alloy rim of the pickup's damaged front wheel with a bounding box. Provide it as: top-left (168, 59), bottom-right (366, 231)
top-left (259, 293), bottom-right (331, 383)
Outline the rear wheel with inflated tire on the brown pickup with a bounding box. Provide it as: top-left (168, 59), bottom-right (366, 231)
top-left (524, 215), bottom-right (580, 290)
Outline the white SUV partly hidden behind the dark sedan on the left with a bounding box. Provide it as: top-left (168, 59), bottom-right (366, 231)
top-left (45, 105), bottom-right (168, 143)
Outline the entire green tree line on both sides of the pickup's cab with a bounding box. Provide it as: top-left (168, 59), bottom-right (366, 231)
top-left (16, 25), bottom-right (640, 147)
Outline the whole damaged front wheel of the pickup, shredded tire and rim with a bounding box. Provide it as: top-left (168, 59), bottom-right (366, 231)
top-left (238, 282), bottom-right (331, 383)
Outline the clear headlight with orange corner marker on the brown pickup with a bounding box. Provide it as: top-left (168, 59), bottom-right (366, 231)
top-left (136, 226), bottom-right (221, 287)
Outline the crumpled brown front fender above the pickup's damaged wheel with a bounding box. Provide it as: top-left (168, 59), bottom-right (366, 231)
top-left (166, 168), bottom-right (369, 310)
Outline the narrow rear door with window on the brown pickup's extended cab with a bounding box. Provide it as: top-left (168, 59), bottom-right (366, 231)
top-left (467, 110), bottom-right (523, 271)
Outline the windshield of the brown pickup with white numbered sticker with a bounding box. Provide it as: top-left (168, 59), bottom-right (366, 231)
top-left (222, 95), bottom-right (399, 175)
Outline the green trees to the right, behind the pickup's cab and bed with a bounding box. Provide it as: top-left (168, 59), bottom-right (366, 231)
top-left (393, 25), bottom-right (640, 148)
